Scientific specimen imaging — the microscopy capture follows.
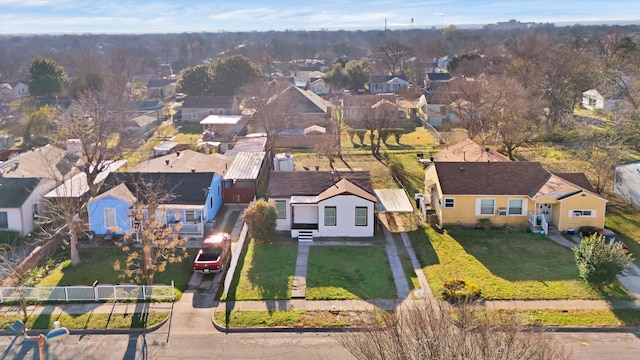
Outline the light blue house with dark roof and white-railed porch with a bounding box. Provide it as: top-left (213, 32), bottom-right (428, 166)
top-left (89, 172), bottom-right (222, 236)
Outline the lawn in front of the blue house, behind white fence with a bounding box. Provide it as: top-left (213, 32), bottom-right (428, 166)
top-left (37, 248), bottom-right (197, 299)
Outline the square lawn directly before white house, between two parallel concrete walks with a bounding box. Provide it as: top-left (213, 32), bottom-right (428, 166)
top-left (306, 246), bottom-right (397, 300)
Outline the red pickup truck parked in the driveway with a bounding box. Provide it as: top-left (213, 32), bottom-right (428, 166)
top-left (193, 232), bottom-right (231, 274)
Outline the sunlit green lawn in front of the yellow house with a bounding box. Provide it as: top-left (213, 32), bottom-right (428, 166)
top-left (409, 227), bottom-right (630, 299)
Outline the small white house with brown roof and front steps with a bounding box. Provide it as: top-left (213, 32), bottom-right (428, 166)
top-left (267, 171), bottom-right (376, 241)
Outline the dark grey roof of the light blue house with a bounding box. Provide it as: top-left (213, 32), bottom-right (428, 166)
top-left (100, 172), bottom-right (216, 205)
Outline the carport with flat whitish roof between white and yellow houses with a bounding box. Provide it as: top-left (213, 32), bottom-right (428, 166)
top-left (373, 189), bottom-right (417, 232)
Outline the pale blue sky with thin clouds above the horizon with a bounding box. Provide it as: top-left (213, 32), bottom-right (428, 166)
top-left (0, 0), bottom-right (640, 34)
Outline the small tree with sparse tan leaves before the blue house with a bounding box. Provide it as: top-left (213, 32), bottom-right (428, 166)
top-left (114, 177), bottom-right (188, 285)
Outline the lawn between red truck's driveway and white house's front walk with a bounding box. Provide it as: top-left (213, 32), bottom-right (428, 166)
top-left (226, 238), bottom-right (298, 301)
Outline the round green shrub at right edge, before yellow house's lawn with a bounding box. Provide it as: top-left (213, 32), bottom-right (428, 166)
top-left (573, 234), bottom-right (632, 290)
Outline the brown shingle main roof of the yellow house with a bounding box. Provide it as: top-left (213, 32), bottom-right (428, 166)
top-left (434, 161), bottom-right (550, 195)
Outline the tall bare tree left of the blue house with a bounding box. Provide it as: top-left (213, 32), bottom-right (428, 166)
top-left (39, 90), bottom-right (132, 266)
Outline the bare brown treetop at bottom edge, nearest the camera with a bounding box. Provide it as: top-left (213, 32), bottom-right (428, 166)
top-left (340, 300), bottom-right (572, 360)
